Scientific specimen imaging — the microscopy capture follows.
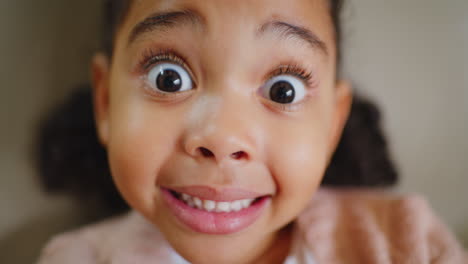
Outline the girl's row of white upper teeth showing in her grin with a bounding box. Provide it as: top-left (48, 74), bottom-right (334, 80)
top-left (181, 193), bottom-right (255, 213)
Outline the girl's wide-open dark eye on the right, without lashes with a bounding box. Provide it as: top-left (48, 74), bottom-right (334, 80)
top-left (261, 75), bottom-right (306, 104)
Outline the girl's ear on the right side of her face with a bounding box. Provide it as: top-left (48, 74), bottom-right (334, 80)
top-left (329, 80), bottom-right (353, 158)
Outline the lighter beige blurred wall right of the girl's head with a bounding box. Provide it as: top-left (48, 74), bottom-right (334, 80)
top-left (345, 0), bottom-right (468, 240)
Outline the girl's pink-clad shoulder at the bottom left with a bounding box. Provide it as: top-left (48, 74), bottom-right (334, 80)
top-left (39, 211), bottom-right (179, 264)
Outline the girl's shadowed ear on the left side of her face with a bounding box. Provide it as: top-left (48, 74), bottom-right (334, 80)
top-left (91, 53), bottom-right (109, 146)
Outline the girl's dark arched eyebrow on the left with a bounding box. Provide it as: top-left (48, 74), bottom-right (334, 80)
top-left (128, 10), bottom-right (203, 44)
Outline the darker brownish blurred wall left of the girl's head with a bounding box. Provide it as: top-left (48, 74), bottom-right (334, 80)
top-left (0, 0), bottom-right (99, 238)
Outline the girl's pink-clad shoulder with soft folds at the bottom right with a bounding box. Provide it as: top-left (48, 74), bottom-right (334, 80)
top-left (297, 189), bottom-right (468, 264)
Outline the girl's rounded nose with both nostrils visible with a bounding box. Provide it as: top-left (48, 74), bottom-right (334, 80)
top-left (183, 97), bottom-right (258, 164)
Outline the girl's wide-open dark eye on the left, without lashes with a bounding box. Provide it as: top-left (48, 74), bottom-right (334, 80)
top-left (147, 62), bottom-right (193, 93)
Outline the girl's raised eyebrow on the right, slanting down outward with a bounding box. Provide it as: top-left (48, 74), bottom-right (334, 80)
top-left (258, 20), bottom-right (328, 55)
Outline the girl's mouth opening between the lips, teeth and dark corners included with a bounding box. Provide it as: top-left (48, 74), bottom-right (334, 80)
top-left (169, 190), bottom-right (266, 213)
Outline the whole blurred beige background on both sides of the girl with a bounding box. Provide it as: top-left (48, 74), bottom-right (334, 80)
top-left (0, 0), bottom-right (468, 263)
